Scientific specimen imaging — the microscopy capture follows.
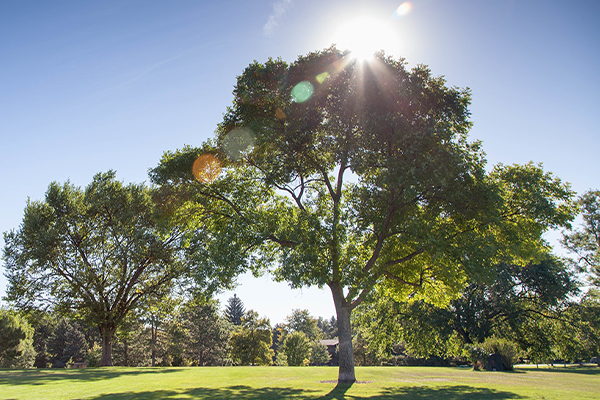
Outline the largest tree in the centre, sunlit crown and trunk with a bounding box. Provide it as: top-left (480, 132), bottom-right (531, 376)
top-left (151, 48), bottom-right (572, 382)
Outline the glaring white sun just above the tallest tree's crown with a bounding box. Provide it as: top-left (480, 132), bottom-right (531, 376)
top-left (334, 16), bottom-right (397, 60)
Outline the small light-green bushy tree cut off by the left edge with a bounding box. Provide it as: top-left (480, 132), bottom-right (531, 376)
top-left (0, 309), bottom-right (35, 368)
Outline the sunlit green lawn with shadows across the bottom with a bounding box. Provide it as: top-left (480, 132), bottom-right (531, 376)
top-left (0, 367), bottom-right (600, 400)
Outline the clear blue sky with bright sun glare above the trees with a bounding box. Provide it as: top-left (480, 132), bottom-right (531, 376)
top-left (0, 0), bottom-right (600, 323)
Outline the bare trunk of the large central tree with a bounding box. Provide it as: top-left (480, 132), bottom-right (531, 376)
top-left (330, 283), bottom-right (356, 383)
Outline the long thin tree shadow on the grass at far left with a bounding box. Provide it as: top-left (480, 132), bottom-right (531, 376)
top-left (0, 367), bottom-right (177, 385)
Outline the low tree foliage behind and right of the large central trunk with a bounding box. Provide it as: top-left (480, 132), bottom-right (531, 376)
top-left (355, 258), bottom-right (578, 361)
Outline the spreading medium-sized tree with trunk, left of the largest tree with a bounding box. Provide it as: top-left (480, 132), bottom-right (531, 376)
top-left (4, 171), bottom-right (188, 366)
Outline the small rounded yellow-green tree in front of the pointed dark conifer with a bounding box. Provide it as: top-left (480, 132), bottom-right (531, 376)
top-left (229, 310), bottom-right (275, 365)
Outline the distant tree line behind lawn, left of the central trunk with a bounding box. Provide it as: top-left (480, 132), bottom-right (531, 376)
top-left (0, 295), bottom-right (342, 368)
